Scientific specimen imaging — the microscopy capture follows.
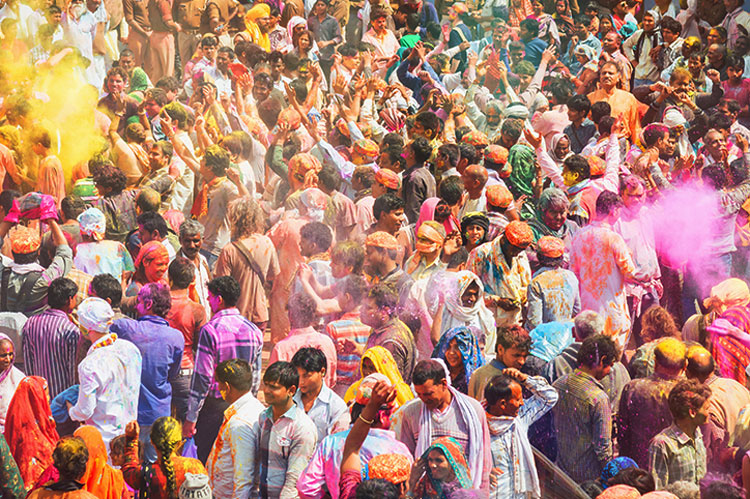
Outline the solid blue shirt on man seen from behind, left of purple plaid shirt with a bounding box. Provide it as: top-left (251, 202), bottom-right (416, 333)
top-left (110, 315), bottom-right (185, 425)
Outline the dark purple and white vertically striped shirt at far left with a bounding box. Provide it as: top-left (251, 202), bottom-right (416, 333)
top-left (22, 308), bottom-right (81, 398)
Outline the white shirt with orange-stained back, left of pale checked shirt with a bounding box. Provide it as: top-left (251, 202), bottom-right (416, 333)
top-left (206, 392), bottom-right (265, 499)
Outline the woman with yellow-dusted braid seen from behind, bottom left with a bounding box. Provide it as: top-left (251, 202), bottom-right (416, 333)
top-left (122, 417), bottom-right (207, 499)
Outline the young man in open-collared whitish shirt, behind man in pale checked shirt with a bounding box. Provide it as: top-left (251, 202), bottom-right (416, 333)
top-left (292, 347), bottom-right (350, 442)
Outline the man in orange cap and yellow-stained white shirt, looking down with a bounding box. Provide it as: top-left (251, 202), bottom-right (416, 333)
top-left (466, 221), bottom-right (534, 327)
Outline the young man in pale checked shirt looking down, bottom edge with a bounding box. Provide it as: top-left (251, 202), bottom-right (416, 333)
top-left (246, 361), bottom-right (317, 499)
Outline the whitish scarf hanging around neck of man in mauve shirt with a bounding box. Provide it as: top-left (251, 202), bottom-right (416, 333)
top-left (414, 390), bottom-right (484, 488)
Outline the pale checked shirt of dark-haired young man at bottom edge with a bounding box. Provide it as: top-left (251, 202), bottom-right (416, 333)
top-left (250, 405), bottom-right (318, 499)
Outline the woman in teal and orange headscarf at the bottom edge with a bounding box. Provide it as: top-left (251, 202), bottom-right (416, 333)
top-left (409, 437), bottom-right (472, 499)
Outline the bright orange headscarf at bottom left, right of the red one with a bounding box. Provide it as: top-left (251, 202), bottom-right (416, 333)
top-left (73, 425), bottom-right (125, 499)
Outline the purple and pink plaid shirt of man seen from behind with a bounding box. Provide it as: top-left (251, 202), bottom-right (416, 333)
top-left (187, 307), bottom-right (263, 422)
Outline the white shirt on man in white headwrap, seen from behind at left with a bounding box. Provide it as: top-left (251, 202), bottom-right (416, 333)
top-left (68, 335), bottom-right (141, 445)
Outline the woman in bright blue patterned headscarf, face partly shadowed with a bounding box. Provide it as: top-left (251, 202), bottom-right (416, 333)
top-left (432, 326), bottom-right (484, 394)
